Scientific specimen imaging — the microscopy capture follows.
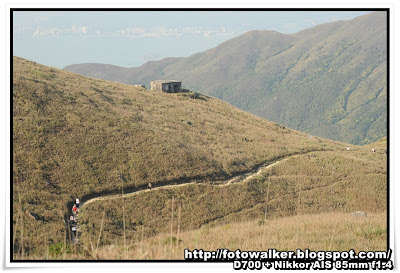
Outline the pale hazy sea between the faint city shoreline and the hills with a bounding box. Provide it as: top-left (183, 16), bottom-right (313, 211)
top-left (12, 35), bottom-right (234, 68)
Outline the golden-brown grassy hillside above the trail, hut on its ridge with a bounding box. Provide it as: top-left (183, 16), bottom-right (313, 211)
top-left (12, 57), bottom-right (336, 258)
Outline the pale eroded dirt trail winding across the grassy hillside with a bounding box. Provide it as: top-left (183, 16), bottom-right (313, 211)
top-left (81, 150), bottom-right (320, 208)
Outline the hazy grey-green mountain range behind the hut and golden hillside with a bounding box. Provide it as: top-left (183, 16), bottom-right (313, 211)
top-left (64, 11), bottom-right (387, 144)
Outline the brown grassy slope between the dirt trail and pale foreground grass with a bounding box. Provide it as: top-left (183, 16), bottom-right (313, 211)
top-left (76, 142), bottom-right (387, 258)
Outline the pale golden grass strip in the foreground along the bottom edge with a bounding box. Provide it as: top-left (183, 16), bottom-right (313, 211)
top-left (91, 212), bottom-right (386, 259)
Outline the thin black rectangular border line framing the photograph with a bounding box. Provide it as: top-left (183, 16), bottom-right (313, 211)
top-left (7, 8), bottom-right (391, 264)
